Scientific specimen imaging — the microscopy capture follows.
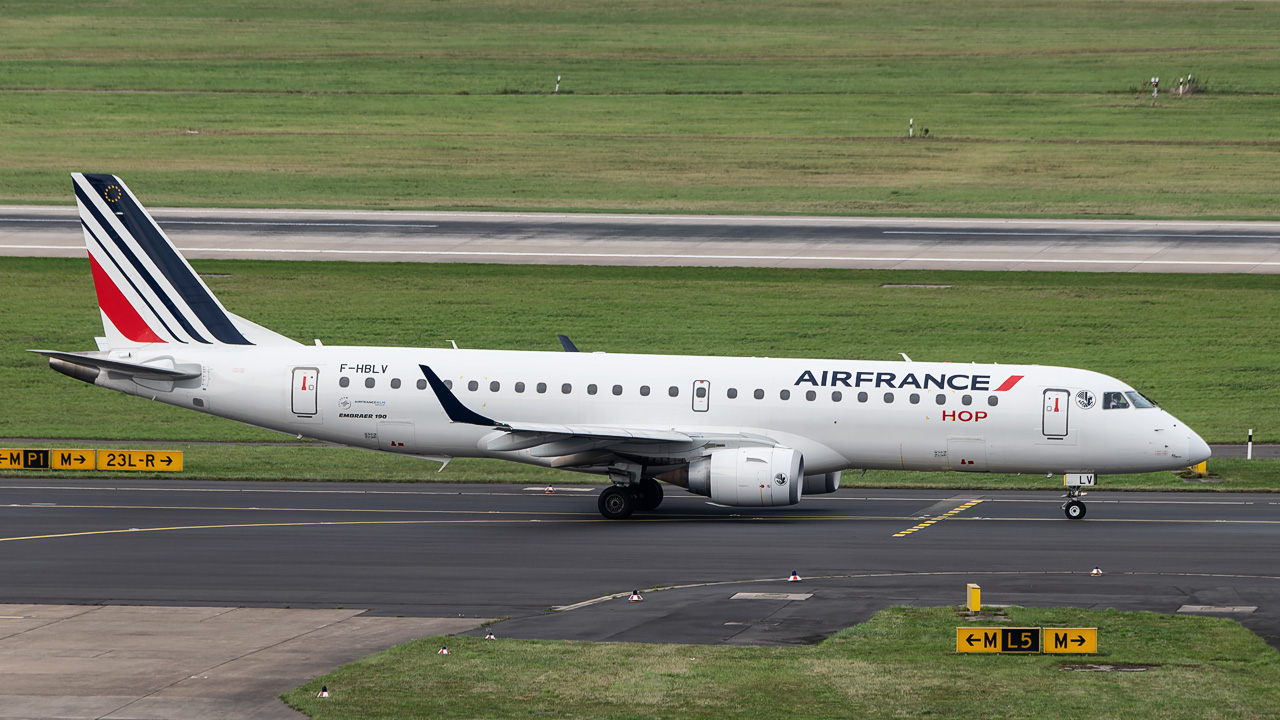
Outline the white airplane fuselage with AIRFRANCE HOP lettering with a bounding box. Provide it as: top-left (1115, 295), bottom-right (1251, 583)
top-left (97, 346), bottom-right (1208, 474)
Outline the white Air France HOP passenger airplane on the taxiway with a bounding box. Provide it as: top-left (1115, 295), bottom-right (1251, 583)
top-left (32, 173), bottom-right (1210, 520)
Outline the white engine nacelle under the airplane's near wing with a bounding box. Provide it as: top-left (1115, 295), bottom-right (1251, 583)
top-left (689, 447), bottom-right (804, 507)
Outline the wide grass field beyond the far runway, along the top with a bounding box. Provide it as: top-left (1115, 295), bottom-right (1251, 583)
top-left (0, 0), bottom-right (1280, 218)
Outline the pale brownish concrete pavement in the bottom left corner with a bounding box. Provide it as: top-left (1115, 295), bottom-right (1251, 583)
top-left (0, 605), bottom-right (484, 720)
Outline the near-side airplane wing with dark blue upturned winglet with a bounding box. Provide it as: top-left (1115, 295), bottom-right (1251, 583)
top-left (419, 365), bottom-right (777, 471)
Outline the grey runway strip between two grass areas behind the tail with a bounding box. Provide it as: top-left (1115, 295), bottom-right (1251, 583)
top-left (0, 205), bottom-right (1280, 273)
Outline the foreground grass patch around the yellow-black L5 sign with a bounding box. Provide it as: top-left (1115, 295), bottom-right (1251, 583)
top-left (283, 607), bottom-right (1280, 720)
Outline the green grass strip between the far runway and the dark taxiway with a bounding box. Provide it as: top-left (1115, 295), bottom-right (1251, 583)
top-left (0, 259), bottom-right (1280, 489)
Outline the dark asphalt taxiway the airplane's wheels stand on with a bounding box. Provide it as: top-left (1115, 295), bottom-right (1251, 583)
top-left (0, 478), bottom-right (1280, 646)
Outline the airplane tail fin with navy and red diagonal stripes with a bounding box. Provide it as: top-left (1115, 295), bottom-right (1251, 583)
top-left (72, 173), bottom-right (298, 347)
